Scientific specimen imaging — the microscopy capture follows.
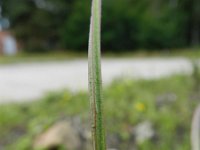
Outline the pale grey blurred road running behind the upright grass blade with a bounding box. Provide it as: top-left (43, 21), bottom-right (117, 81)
top-left (0, 58), bottom-right (192, 103)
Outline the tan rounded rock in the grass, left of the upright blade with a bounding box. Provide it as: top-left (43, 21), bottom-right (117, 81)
top-left (33, 121), bottom-right (81, 150)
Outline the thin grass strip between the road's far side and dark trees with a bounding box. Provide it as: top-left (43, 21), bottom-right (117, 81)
top-left (0, 48), bottom-right (200, 64)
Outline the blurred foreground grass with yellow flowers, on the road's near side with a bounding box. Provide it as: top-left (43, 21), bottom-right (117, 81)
top-left (0, 76), bottom-right (200, 150)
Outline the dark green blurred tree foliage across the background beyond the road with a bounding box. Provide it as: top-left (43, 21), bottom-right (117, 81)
top-left (2, 0), bottom-right (200, 51)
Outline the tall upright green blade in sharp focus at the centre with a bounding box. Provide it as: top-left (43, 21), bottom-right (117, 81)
top-left (88, 0), bottom-right (106, 150)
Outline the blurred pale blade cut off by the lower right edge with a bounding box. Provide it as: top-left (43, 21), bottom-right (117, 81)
top-left (191, 105), bottom-right (200, 150)
